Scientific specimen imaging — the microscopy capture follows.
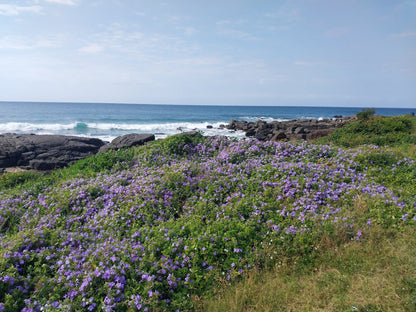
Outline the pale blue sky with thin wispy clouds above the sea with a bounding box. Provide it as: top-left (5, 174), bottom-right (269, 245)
top-left (0, 0), bottom-right (416, 107)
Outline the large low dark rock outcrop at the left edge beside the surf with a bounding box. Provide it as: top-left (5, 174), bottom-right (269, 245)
top-left (0, 134), bottom-right (104, 170)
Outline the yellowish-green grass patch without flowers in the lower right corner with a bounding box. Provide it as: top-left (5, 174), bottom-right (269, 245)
top-left (200, 227), bottom-right (416, 312)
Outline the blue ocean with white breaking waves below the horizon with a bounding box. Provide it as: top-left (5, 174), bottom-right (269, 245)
top-left (0, 102), bottom-right (416, 141)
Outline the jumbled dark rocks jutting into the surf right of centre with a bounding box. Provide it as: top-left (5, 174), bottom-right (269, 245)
top-left (227, 116), bottom-right (356, 141)
